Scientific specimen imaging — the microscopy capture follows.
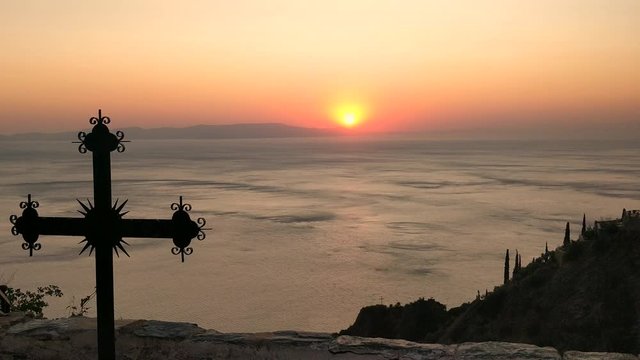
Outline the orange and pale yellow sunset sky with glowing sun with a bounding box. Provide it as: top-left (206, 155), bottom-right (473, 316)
top-left (0, 0), bottom-right (640, 134)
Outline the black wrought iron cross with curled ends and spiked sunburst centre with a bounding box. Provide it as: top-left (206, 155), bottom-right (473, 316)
top-left (10, 110), bottom-right (208, 360)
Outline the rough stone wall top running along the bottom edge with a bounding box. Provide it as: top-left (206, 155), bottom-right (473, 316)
top-left (0, 313), bottom-right (638, 360)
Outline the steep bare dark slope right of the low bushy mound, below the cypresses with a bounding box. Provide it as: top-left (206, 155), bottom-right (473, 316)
top-left (440, 222), bottom-right (640, 354)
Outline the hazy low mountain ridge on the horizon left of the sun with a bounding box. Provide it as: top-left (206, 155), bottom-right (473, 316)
top-left (0, 123), bottom-right (343, 140)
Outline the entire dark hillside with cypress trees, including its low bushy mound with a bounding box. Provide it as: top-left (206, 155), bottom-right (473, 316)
top-left (340, 210), bottom-right (640, 354)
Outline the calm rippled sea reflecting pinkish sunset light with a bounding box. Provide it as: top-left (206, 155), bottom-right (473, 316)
top-left (0, 137), bottom-right (640, 331)
